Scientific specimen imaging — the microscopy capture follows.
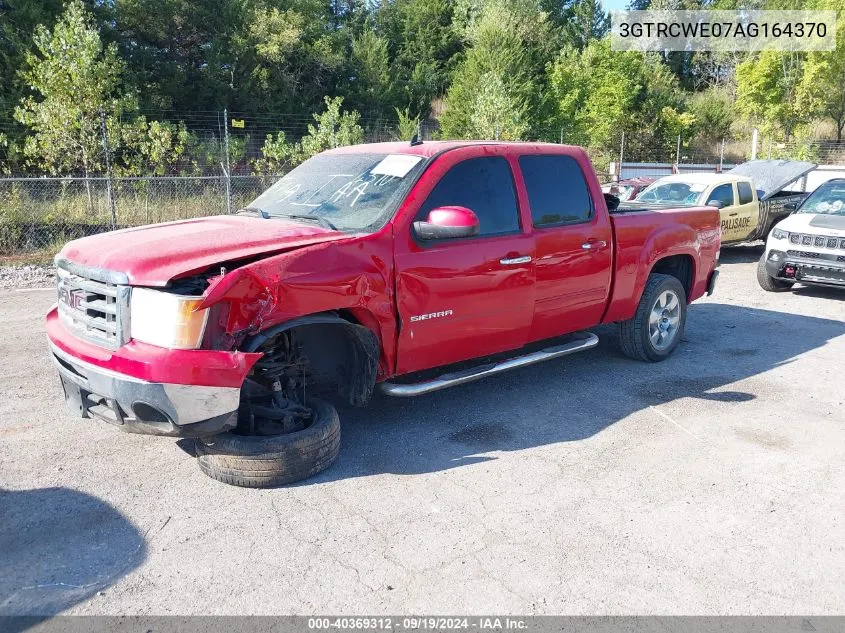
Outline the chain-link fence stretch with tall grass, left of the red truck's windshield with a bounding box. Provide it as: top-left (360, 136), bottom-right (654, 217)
top-left (0, 176), bottom-right (278, 255)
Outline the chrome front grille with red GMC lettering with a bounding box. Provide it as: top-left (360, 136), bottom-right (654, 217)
top-left (57, 268), bottom-right (129, 349)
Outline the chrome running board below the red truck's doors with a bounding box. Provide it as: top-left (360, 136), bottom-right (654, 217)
top-left (378, 332), bottom-right (599, 398)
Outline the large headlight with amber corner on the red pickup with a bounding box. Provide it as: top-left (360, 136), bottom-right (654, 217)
top-left (129, 288), bottom-right (213, 349)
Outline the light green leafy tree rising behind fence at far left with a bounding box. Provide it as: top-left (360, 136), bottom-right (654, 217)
top-left (15, 0), bottom-right (133, 176)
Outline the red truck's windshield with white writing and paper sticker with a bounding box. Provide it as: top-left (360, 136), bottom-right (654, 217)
top-left (247, 154), bottom-right (424, 231)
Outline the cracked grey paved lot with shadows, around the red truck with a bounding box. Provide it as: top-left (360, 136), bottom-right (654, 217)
top-left (0, 248), bottom-right (845, 614)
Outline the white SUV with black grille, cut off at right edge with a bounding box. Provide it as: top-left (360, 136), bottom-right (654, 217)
top-left (757, 178), bottom-right (845, 292)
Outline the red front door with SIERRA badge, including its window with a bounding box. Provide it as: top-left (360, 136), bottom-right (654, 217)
top-left (394, 147), bottom-right (534, 374)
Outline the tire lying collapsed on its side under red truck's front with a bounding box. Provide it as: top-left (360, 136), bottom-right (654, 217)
top-left (195, 398), bottom-right (340, 488)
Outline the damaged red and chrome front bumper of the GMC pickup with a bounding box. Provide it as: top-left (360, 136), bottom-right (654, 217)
top-left (47, 310), bottom-right (260, 437)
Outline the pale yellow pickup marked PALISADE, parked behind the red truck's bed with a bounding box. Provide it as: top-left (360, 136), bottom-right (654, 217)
top-left (627, 160), bottom-right (816, 246)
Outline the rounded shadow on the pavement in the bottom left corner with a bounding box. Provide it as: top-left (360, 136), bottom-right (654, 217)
top-left (0, 488), bottom-right (146, 616)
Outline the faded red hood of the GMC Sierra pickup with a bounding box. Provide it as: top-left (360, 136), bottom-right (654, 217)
top-left (56, 215), bottom-right (350, 286)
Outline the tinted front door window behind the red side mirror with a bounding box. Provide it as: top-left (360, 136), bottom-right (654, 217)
top-left (417, 156), bottom-right (519, 235)
